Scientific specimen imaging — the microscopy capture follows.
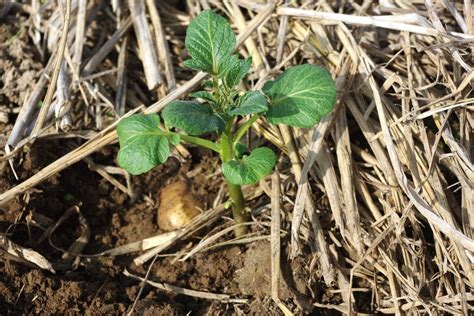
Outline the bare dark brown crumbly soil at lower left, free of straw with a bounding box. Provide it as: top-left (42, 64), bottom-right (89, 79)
top-left (0, 141), bottom-right (298, 315)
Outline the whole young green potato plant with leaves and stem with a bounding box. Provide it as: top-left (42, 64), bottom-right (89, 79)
top-left (117, 10), bottom-right (336, 236)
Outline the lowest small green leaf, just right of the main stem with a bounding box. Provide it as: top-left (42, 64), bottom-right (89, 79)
top-left (222, 147), bottom-right (276, 185)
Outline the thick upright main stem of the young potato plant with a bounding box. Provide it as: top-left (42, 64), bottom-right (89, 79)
top-left (221, 129), bottom-right (250, 237)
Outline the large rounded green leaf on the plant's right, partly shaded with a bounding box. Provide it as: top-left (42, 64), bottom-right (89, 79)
top-left (262, 64), bottom-right (336, 127)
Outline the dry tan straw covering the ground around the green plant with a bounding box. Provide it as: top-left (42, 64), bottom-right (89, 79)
top-left (0, 0), bottom-right (474, 315)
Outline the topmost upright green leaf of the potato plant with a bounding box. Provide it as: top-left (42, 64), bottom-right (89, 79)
top-left (185, 10), bottom-right (235, 75)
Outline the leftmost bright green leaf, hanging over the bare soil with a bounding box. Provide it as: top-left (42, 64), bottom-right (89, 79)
top-left (117, 114), bottom-right (170, 175)
